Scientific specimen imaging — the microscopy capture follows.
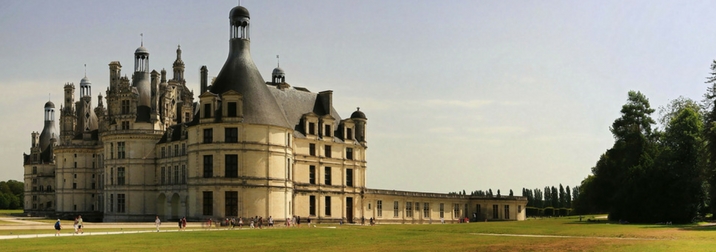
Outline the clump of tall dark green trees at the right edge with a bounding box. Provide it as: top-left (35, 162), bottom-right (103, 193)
top-left (574, 60), bottom-right (716, 223)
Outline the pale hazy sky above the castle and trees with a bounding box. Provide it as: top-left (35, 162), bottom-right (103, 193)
top-left (0, 0), bottom-right (716, 195)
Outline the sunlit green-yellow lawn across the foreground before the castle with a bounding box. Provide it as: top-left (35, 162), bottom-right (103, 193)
top-left (0, 218), bottom-right (716, 251)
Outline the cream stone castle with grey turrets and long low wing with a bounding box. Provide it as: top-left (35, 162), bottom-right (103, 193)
top-left (23, 6), bottom-right (527, 223)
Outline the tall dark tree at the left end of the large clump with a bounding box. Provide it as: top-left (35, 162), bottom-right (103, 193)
top-left (580, 91), bottom-right (658, 221)
